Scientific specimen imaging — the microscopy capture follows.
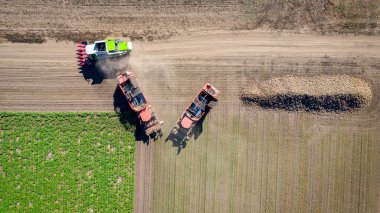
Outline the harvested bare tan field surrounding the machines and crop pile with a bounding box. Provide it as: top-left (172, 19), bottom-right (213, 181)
top-left (0, 32), bottom-right (380, 212)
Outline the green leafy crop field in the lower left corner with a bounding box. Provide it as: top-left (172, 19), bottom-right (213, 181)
top-left (0, 113), bottom-right (135, 212)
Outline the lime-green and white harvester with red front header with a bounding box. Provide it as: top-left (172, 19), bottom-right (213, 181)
top-left (77, 39), bottom-right (132, 66)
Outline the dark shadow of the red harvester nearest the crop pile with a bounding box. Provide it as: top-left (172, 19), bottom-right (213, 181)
top-left (165, 108), bottom-right (210, 155)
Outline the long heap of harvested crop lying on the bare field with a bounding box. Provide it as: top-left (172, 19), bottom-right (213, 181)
top-left (240, 75), bottom-right (372, 112)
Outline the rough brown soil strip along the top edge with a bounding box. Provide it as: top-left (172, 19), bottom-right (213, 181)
top-left (0, 0), bottom-right (380, 43)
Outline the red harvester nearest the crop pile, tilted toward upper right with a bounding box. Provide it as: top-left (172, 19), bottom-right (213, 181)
top-left (167, 83), bottom-right (220, 148)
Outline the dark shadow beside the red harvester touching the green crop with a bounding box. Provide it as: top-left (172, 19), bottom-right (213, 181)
top-left (113, 86), bottom-right (149, 145)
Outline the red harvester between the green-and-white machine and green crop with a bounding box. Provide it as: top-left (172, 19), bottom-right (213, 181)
top-left (117, 70), bottom-right (163, 140)
